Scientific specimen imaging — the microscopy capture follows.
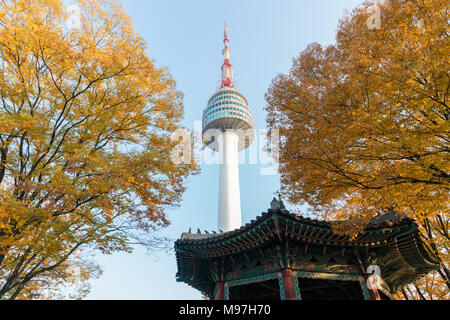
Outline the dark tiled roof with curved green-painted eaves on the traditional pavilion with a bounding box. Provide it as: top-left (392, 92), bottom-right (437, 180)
top-left (175, 201), bottom-right (437, 296)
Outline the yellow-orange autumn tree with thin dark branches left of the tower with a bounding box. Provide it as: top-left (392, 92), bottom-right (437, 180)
top-left (0, 0), bottom-right (197, 299)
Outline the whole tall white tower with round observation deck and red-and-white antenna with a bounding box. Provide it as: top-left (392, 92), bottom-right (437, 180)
top-left (203, 24), bottom-right (254, 232)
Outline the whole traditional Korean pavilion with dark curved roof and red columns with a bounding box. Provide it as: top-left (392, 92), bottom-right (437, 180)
top-left (175, 199), bottom-right (438, 300)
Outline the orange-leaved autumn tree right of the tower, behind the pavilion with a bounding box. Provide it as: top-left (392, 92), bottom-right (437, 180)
top-left (266, 0), bottom-right (450, 299)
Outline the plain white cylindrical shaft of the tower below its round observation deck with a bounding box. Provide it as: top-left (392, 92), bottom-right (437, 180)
top-left (218, 131), bottom-right (242, 232)
